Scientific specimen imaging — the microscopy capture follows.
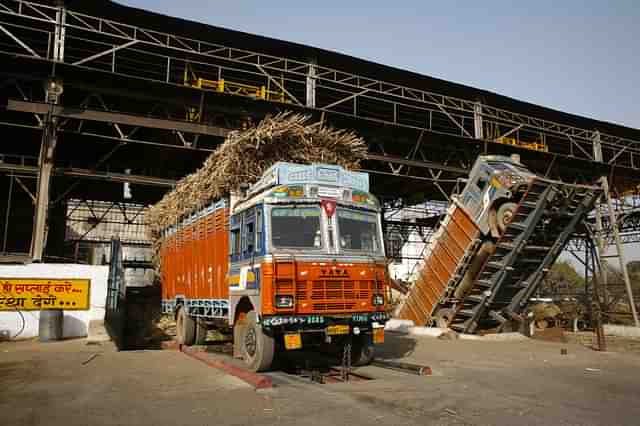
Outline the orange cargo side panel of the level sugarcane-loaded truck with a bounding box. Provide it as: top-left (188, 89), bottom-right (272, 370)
top-left (160, 209), bottom-right (229, 299)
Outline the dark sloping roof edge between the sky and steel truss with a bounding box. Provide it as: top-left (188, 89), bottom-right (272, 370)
top-left (55, 0), bottom-right (640, 141)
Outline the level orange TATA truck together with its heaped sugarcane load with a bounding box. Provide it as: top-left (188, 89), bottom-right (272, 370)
top-left (148, 114), bottom-right (388, 371)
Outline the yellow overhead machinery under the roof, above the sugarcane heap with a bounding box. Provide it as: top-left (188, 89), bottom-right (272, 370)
top-left (183, 63), bottom-right (288, 121)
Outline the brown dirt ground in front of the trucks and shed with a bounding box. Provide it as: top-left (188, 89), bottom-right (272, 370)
top-left (0, 333), bottom-right (640, 426)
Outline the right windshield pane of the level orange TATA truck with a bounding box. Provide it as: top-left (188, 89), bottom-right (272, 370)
top-left (338, 209), bottom-right (381, 253)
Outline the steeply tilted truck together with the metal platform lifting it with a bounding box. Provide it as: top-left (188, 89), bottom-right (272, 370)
top-left (395, 155), bottom-right (602, 333)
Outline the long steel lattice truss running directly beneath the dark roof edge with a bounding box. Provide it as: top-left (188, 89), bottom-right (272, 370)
top-left (0, 0), bottom-right (640, 168)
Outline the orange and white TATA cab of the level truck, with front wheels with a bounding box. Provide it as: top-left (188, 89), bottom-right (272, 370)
top-left (228, 163), bottom-right (388, 369)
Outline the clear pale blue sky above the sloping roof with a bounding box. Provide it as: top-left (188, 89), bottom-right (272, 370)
top-left (118, 0), bottom-right (640, 128)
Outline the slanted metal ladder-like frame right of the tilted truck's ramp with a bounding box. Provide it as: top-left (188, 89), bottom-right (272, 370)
top-left (596, 176), bottom-right (640, 327)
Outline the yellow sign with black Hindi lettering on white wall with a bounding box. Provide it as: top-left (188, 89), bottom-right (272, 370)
top-left (0, 278), bottom-right (91, 311)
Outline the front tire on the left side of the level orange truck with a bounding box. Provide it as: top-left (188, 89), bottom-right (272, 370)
top-left (241, 311), bottom-right (275, 371)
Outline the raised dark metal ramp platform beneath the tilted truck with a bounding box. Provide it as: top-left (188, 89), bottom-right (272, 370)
top-left (448, 178), bottom-right (601, 333)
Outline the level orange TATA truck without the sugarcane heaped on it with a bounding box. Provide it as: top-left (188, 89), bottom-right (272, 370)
top-left (160, 162), bottom-right (389, 371)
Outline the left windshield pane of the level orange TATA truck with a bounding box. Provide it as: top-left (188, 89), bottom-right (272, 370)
top-left (271, 207), bottom-right (322, 248)
